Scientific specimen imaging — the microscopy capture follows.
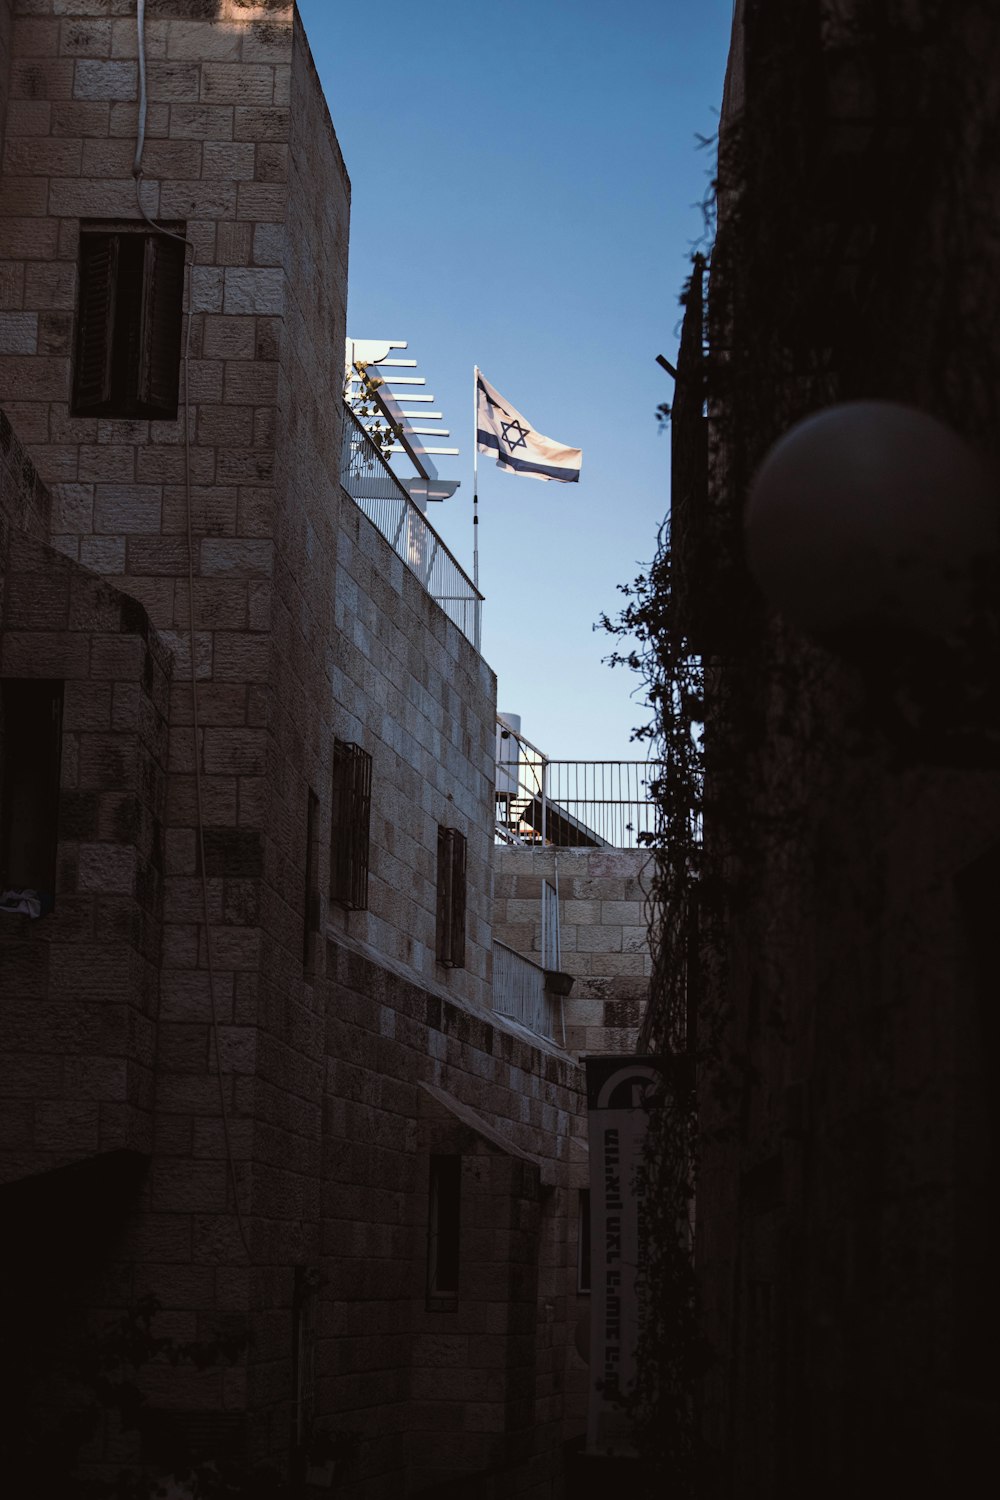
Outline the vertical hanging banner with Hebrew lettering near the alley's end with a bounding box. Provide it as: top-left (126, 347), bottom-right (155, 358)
top-left (585, 1053), bottom-right (661, 1455)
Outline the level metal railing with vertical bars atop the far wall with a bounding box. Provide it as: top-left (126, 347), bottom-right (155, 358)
top-left (496, 720), bottom-right (663, 849)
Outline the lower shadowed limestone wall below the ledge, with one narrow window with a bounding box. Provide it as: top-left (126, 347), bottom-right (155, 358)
top-left (316, 944), bottom-right (586, 1500)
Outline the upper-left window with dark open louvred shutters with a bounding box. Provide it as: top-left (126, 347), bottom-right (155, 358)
top-left (73, 227), bottom-right (184, 422)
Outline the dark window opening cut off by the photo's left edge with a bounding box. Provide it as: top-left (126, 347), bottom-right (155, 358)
top-left (0, 678), bottom-right (63, 915)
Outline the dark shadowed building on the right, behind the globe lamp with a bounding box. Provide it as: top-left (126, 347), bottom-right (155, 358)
top-left (656, 0), bottom-right (1000, 1497)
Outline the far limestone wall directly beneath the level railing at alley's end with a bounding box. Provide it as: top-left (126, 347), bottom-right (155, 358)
top-left (493, 846), bottom-right (652, 1053)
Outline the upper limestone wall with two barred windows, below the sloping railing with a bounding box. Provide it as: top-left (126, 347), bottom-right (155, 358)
top-left (330, 497), bottom-right (496, 1008)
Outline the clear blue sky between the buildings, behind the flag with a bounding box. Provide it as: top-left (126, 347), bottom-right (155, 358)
top-left (298, 0), bottom-right (732, 759)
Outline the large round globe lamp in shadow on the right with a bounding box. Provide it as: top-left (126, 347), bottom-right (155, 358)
top-left (745, 401), bottom-right (1000, 638)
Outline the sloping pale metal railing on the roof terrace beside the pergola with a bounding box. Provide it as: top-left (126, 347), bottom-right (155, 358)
top-left (340, 407), bottom-right (483, 651)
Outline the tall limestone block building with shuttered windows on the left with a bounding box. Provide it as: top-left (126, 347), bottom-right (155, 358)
top-left (0, 0), bottom-right (650, 1497)
